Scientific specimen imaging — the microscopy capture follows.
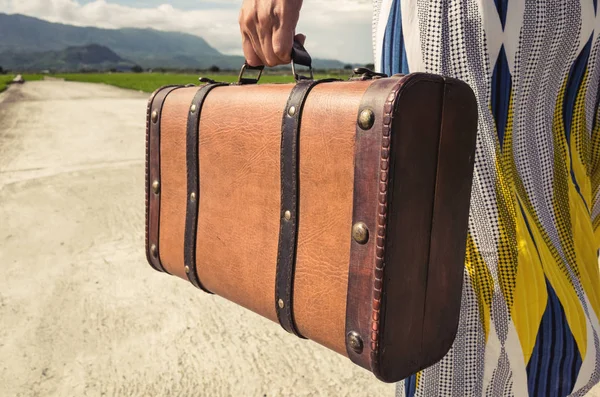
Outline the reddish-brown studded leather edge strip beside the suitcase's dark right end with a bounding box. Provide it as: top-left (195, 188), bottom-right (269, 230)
top-left (346, 79), bottom-right (403, 370)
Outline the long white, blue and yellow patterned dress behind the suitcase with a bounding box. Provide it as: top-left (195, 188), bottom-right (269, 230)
top-left (373, 0), bottom-right (600, 397)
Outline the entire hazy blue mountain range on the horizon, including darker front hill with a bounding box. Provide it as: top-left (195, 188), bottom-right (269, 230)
top-left (0, 13), bottom-right (344, 71)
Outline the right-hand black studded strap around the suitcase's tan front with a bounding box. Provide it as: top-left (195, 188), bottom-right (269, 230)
top-left (275, 80), bottom-right (334, 337)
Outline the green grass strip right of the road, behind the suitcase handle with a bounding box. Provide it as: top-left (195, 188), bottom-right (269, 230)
top-left (54, 71), bottom-right (350, 92)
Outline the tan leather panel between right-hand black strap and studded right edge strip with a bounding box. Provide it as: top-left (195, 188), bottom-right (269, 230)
top-left (293, 80), bottom-right (375, 355)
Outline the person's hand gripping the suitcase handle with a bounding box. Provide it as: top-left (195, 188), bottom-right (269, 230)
top-left (239, 0), bottom-right (305, 66)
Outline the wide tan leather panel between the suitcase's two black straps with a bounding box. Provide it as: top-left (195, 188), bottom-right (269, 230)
top-left (196, 84), bottom-right (294, 321)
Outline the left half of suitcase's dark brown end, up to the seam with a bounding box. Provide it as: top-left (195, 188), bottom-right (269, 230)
top-left (371, 73), bottom-right (448, 382)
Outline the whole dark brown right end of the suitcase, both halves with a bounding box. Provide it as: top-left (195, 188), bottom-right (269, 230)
top-left (371, 73), bottom-right (477, 382)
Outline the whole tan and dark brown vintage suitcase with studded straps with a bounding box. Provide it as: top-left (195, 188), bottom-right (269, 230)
top-left (146, 48), bottom-right (477, 382)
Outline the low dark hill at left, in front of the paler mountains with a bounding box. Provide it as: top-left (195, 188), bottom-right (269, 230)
top-left (0, 44), bottom-right (134, 72)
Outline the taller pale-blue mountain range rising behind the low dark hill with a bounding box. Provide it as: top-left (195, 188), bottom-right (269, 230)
top-left (0, 13), bottom-right (343, 70)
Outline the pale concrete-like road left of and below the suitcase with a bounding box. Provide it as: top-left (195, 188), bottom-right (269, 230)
top-left (0, 81), bottom-right (394, 397)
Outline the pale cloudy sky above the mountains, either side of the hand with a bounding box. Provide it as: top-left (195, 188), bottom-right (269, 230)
top-left (0, 0), bottom-right (373, 63)
